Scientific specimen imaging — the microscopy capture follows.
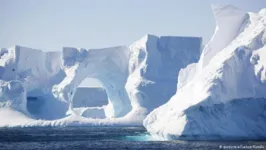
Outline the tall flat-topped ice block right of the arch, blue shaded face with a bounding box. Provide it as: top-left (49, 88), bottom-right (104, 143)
top-left (126, 35), bottom-right (201, 115)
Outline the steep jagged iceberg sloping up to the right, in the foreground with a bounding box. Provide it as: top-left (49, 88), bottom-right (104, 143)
top-left (144, 5), bottom-right (266, 139)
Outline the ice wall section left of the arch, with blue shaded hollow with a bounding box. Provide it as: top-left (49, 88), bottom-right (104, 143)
top-left (0, 46), bottom-right (68, 120)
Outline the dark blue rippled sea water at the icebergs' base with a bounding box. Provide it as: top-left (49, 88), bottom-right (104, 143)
top-left (0, 127), bottom-right (266, 150)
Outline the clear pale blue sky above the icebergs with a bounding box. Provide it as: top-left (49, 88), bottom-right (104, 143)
top-left (0, 0), bottom-right (266, 86)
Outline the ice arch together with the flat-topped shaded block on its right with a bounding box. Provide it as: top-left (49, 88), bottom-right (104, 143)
top-left (53, 35), bottom-right (201, 121)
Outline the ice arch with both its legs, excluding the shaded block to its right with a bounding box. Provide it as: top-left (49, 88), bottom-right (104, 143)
top-left (53, 46), bottom-right (131, 117)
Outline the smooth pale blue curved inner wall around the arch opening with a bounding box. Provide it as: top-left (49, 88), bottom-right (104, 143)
top-left (66, 67), bottom-right (132, 118)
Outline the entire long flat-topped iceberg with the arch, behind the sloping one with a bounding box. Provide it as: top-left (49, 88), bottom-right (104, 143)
top-left (0, 35), bottom-right (201, 124)
